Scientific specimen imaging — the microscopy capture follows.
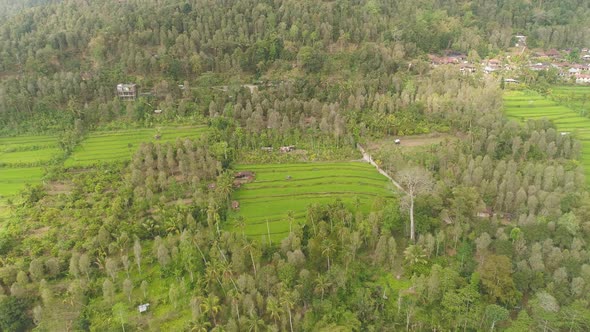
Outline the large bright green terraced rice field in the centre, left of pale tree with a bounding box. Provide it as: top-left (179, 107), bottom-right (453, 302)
top-left (229, 162), bottom-right (394, 239)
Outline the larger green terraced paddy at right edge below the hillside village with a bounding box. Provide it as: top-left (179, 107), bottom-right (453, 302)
top-left (504, 91), bottom-right (590, 184)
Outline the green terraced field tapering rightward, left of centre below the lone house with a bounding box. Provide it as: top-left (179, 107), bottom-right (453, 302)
top-left (65, 126), bottom-right (207, 167)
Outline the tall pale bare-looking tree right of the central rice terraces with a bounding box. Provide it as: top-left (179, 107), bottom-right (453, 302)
top-left (397, 167), bottom-right (433, 242)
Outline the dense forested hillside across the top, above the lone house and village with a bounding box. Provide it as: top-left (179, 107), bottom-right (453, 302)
top-left (0, 0), bottom-right (590, 131)
